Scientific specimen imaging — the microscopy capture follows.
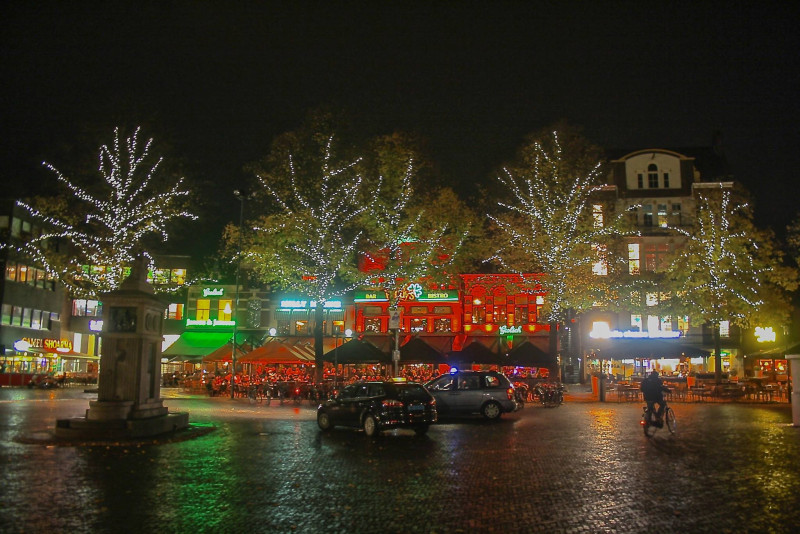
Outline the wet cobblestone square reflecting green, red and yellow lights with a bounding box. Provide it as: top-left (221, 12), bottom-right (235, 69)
top-left (0, 388), bottom-right (800, 533)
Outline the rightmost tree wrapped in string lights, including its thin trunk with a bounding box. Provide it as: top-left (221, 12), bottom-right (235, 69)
top-left (665, 183), bottom-right (798, 382)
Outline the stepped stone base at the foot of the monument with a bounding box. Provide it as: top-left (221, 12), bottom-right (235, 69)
top-left (55, 399), bottom-right (189, 440)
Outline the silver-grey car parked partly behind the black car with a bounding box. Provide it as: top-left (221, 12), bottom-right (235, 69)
top-left (425, 369), bottom-right (518, 420)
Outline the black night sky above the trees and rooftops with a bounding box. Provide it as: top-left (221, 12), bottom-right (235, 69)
top-left (0, 0), bottom-right (800, 247)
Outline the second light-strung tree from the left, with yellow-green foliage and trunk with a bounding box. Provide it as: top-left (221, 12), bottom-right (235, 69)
top-left (238, 124), bottom-right (381, 381)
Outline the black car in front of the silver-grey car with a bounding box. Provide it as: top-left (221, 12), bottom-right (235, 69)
top-left (317, 382), bottom-right (437, 436)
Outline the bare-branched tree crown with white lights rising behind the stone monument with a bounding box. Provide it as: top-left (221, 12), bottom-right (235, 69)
top-left (9, 128), bottom-right (196, 298)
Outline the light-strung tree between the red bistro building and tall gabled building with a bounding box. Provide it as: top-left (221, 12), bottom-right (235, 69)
top-left (488, 125), bottom-right (625, 378)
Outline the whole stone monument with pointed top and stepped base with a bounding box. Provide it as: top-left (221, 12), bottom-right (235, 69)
top-left (55, 257), bottom-right (189, 439)
